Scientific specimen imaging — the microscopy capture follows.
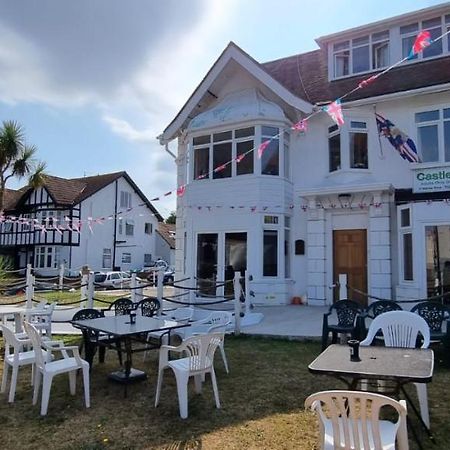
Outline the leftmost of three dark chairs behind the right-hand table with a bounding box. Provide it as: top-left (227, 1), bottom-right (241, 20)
top-left (322, 300), bottom-right (362, 350)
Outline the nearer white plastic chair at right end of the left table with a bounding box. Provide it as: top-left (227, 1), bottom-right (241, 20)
top-left (155, 333), bottom-right (224, 419)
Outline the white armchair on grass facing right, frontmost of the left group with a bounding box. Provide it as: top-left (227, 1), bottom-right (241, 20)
top-left (24, 322), bottom-right (90, 416)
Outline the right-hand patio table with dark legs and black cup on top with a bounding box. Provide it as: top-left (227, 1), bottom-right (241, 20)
top-left (308, 344), bottom-right (434, 446)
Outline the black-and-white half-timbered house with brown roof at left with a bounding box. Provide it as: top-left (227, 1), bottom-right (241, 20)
top-left (0, 172), bottom-right (163, 275)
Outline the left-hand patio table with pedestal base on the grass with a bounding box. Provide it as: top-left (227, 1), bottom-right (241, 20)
top-left (71, 315), bottom-right (190, 395)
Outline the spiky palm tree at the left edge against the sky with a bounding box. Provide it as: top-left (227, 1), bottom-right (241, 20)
top-left (0, 120), bottom-right (45, 212)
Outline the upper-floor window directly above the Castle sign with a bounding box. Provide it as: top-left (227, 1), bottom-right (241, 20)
top-left (415, 108), bottom-right (450, 162)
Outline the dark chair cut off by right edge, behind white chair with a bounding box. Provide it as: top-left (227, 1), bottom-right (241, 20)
top-left (411, 300), bottom-right (450, 346)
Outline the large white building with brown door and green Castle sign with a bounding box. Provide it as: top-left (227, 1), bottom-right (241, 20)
top-left (160, 3), bottom-right (450, 305)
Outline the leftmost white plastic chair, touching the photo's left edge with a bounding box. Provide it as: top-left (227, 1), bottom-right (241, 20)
top-left (0, 325), bottom-right (39, 403)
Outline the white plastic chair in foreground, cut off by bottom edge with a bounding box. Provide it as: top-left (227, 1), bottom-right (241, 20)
top-left (305, 391), bottom-right (409, 450)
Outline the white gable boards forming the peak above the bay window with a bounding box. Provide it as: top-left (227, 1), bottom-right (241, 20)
top-left (159, 42), bottom-right (312, 144)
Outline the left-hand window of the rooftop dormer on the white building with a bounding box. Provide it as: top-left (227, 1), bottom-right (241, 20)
top-left (333, 30), bottom-right (389, 78)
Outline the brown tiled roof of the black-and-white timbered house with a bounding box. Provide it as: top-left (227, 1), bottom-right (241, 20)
top-left (5, 171), bottom-right (163, 221)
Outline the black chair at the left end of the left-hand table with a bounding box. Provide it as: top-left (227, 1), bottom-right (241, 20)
top-left (72, 308), bottom-right (122, 367)
